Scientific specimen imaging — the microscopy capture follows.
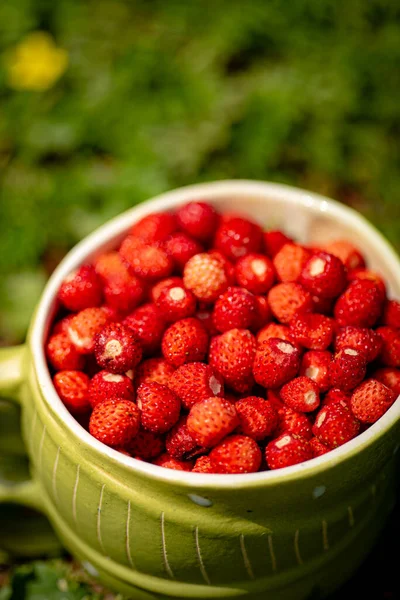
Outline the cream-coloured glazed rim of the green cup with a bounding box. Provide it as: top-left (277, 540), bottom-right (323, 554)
top-left (29, 179), bottom-right (400, 489)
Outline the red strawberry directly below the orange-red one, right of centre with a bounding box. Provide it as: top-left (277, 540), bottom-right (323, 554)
top-left (290, 313), bottom-right (335, 350)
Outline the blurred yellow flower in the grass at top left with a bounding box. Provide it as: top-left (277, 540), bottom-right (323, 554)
top-left (6, 31), bottom-right (68, 91)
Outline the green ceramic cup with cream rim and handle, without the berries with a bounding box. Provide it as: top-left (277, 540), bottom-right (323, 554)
top-left (0, 181), bottom-right (400, 600)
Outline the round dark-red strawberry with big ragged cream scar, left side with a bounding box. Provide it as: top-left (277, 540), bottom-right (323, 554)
top-left (94, 323), bottom-right (142, 373)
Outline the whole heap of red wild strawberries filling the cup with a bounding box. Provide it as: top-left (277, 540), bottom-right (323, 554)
top-left (46, 202), bottom-right (400, 473)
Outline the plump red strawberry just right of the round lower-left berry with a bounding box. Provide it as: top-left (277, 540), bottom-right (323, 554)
top-left (137, 381), bottom-right (181, 433)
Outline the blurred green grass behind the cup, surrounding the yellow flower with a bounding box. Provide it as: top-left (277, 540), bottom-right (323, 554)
top-left (0, 0), bottom-right (400, 343)
